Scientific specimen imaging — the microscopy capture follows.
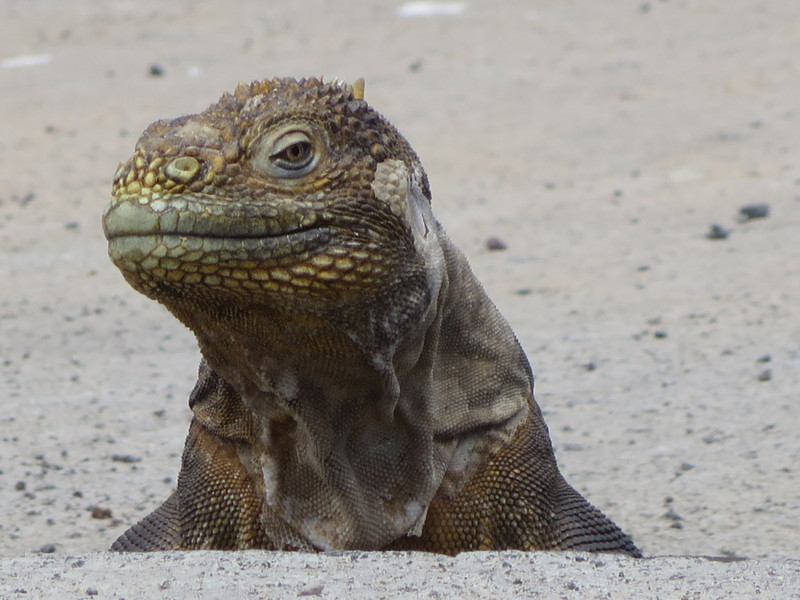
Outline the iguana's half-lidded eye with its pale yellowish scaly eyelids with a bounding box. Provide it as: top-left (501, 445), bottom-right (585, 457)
top-left (253, 125), bottom-right (319, 179)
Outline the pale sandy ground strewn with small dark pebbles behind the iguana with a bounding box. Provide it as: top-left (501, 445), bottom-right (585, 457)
top-left (0, 0), bottom-right (800, 597)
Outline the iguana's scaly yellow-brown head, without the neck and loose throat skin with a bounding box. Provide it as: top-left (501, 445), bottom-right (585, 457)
top-left (103, 79), bottom-right (433, 328)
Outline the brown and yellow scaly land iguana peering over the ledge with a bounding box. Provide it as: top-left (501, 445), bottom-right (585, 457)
top-left (103, 79), bottom-right (640, 556)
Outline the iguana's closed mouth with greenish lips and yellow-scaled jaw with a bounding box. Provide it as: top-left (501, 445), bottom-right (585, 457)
top-left (103, 195), bottom-right (383, 299)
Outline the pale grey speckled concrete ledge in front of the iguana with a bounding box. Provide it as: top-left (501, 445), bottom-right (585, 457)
top-left (0, 551), bottom-right (800, 600)
